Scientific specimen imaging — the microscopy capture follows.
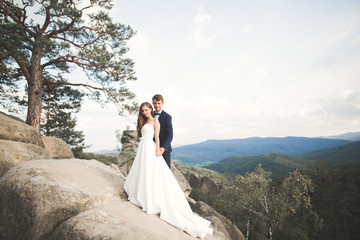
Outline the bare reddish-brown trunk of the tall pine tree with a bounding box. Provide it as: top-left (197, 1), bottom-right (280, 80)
top-left (26, 44), bottom-right (42, 132)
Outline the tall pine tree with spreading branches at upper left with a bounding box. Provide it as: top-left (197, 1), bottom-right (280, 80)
top-left (0, 0), bottom-right (137, 131)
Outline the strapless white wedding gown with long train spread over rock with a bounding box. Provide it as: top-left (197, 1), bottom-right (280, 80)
top-left (124, 124), bottom-right (213, 238)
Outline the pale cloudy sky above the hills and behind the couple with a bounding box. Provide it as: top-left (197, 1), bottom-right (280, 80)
top-left (77, 0), bottom-right (360, 151)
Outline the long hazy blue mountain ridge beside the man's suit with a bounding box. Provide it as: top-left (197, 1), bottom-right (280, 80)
top-left (172, 137), bottom-right (350, 166)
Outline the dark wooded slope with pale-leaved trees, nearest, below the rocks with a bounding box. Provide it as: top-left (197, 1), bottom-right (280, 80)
top-left (180, 164), bottom-right (360, 240)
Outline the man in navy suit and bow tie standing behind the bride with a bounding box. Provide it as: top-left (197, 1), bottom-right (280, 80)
top-left (152, 94), bottom-right (173, 168)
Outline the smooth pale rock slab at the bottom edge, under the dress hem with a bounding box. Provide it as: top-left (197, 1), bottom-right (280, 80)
top-left (49, 201), bottom-right (202, 240)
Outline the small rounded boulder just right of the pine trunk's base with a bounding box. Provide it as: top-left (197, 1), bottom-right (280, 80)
top-left (41, 136), bottom-right (74, 159)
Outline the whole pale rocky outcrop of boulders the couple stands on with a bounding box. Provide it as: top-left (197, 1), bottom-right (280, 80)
top-left (0, 114), bottom-right (244, 240)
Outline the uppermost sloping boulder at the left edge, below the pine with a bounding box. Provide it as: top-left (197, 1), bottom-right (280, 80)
top-left (0, 112), bottom-right (44, 147)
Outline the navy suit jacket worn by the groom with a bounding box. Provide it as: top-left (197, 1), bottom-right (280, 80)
top-left (158, 110), bottom-right (173, 152)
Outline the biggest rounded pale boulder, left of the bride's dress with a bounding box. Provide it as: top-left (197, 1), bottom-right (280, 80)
top-left (0, 159), bottom-right (127, 240)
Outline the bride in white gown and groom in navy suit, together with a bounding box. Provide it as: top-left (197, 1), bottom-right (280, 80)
top-left (124, 94), bottom-right (213, 238)
